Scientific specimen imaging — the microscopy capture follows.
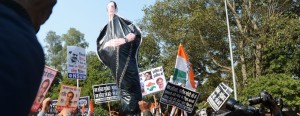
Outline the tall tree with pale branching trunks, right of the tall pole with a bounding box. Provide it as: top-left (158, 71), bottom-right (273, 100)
top-left (227, 0), bottom-right (300, 82)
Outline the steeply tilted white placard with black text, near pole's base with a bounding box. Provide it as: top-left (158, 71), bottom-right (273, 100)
top-left (207, 83), bottom-right (232, 111)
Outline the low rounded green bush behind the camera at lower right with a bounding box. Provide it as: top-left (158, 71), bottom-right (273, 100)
top-left (238, 74), bottom-right (300, 106)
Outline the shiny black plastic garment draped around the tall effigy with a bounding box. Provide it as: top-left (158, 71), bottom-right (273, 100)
top-left (97, 15), bottom-right (142, 115)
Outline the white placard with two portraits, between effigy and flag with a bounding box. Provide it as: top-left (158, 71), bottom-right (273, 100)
top-left (139, 66), bottom-right (167, 96)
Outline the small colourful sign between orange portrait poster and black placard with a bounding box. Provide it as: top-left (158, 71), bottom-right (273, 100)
top-left (78, 96), bottom-right (90, 116)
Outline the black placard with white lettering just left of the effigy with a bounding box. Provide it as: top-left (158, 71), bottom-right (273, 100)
top-left (93, 83), bottom-right (120, 104)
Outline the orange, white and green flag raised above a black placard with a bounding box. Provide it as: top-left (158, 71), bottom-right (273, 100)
top-left (173, 44), bottom-right (196, 91)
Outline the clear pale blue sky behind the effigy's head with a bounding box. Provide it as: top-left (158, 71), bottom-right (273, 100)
top-left (37, 0), bottom-right (155, 52)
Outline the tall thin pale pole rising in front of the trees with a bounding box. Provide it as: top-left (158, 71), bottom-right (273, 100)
top-left (224, 0), bottom-right (237, 100)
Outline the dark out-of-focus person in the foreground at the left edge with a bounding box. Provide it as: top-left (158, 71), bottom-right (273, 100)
top-left (0, 0), bottom-right (56, 116)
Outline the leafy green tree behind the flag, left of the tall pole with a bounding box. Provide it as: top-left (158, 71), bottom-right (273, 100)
top-left (142, 0), bottom-right (230, 79)
